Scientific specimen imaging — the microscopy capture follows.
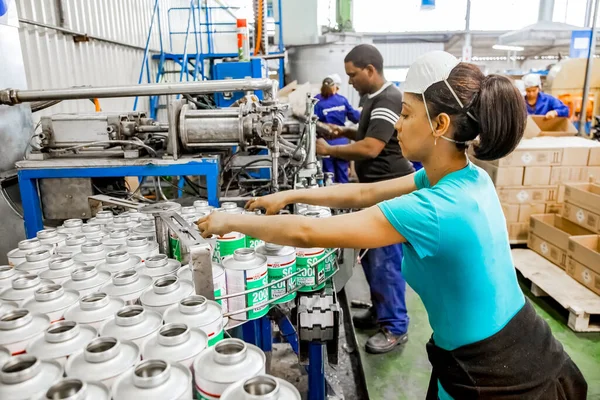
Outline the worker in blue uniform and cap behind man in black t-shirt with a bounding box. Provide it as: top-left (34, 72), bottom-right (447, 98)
top-left (315, 74), bottom-right (360, 183)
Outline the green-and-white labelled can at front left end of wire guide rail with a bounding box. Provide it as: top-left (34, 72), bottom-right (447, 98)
top-left (223, 248), bottom-right (269, 321)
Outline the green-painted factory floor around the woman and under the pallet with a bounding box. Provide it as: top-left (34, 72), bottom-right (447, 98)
top-left (346, 266), bottom-right (600, 400)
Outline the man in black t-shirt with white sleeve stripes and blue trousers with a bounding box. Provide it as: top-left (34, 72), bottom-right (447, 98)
top-left (317, 44), bottom-right (414, 353)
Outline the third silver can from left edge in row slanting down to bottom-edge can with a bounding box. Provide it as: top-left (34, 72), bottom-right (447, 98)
top-left (65, 336), bottom-right (140, 389)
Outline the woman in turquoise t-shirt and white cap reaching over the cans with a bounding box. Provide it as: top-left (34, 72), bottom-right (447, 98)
top-left (198, 52), bottom-right (587, 399)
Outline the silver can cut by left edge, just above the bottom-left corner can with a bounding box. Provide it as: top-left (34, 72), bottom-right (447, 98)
top-left (0, 308), bottom-right (50, 354)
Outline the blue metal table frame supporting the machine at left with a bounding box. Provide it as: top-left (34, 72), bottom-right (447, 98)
top-left (17, 158), bottom-right (219, 238)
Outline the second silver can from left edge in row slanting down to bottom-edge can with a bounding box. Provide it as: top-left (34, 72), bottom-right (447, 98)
top-left (25, 321), bottom-right (98, 368)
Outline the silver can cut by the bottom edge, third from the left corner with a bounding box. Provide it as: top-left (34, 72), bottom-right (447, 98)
top-left (112, 360), bottom-right (192, 400)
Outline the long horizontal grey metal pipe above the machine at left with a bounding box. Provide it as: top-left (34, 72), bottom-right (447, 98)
top-left (0, 78), bottom-right (277, 105)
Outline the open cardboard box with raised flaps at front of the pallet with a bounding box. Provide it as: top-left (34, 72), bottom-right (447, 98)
top-left (527, 214), bottom-right (593, 269)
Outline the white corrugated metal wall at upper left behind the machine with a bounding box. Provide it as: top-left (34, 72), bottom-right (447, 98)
top-left (17, 0), bottom-right (170, 117)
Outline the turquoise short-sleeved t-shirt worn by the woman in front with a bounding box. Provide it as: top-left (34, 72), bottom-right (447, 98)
top-left (379, 162), bottom-right (525, 400)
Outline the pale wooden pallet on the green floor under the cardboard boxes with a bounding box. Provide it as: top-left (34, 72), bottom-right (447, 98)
top-left (512, 249), bottom-right (600, 332)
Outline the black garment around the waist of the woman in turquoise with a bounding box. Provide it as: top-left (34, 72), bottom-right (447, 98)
top-left (426, 301), bottom-right (587, 400)
